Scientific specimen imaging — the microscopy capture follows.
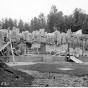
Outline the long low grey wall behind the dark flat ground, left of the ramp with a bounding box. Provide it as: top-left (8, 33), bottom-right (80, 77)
top-left (9, 55), bottom-right (65, 62)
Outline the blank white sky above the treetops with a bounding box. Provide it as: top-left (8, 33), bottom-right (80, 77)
top-left (0, 0), bottom-right (88, 22)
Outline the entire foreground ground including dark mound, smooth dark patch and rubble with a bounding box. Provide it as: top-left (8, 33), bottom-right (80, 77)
top-left (0, 62), bottom-right (88, 87)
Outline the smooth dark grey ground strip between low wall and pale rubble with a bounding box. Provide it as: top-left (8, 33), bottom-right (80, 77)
top-left (13, 62), bottom-right (88, 76)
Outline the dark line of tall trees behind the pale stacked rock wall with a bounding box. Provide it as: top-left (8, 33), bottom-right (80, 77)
top-left (2, 5), bottom-right (88, 33)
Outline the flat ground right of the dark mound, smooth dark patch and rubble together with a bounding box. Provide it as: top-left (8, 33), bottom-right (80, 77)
top-left (10, 62), bottom-right (88, 87)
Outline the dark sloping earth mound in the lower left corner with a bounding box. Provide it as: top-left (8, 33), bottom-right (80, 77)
top-left (0, 62), bottom-right (34, 87)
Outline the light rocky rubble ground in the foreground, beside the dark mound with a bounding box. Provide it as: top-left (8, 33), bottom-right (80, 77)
top-left (19, 70), bottom-right (88, 87)
